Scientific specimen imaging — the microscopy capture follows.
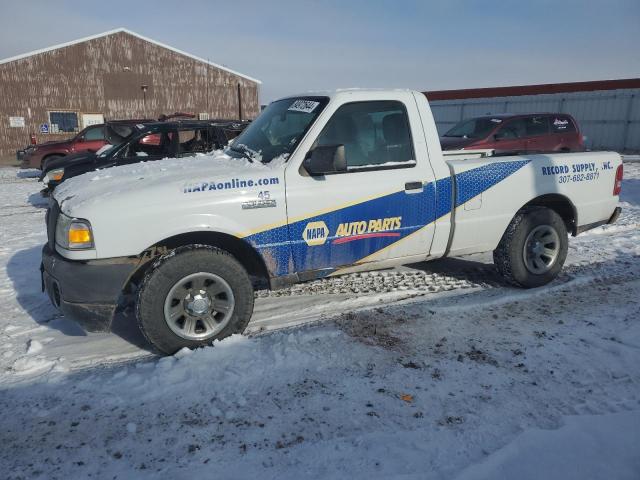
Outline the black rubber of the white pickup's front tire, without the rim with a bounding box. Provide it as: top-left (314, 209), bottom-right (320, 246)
top-left (136, 245), bottom-right (254, 355)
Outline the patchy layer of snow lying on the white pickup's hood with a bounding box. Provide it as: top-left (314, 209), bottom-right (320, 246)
top-left (54, 150), bottom-right (286, 212)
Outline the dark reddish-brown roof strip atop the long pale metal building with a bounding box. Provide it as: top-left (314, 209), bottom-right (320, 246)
top-left (423, 78), bottom-right (640, 101)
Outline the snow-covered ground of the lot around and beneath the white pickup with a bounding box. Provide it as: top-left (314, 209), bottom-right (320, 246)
top-left (0, 163), bottom-right (640, 479)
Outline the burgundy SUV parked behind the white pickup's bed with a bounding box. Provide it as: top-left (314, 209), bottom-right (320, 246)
top-left (440, 113), bottom-right (584, 152)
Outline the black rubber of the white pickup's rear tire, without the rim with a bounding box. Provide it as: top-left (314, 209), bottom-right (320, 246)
top-left (493, 207), bottom-right (568, 288)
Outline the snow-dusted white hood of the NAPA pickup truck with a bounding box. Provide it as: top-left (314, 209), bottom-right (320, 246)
top-left (54, 150), bottom-right (285, 219)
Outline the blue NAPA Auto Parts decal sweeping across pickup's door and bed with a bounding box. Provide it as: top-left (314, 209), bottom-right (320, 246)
top-left (246, 160), bottom-right (529, 276)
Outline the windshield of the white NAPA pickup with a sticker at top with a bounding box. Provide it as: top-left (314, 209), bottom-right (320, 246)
top-left (227, 97), bottom-right (329, 163)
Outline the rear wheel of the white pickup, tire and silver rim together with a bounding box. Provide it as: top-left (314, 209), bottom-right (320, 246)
top-left (493, 207), bottom-right (568, 288)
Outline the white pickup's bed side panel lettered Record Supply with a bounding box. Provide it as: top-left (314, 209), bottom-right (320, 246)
top-left (445, 152), bottom-right (620, 255)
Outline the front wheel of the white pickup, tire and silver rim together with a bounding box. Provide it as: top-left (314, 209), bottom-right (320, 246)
top-left (136, 245), bottom-right (254, 355)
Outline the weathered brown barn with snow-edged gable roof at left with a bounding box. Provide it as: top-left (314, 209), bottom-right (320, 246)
top-left (0, 28), bottom-right (260, 159)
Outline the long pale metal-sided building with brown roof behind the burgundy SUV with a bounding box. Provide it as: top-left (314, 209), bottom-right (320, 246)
top-left (424, 78), bottom-right (640, 153)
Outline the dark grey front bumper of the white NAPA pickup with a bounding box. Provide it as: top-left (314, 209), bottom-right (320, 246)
top-left (40, 244), bottom-right (138, 332)
